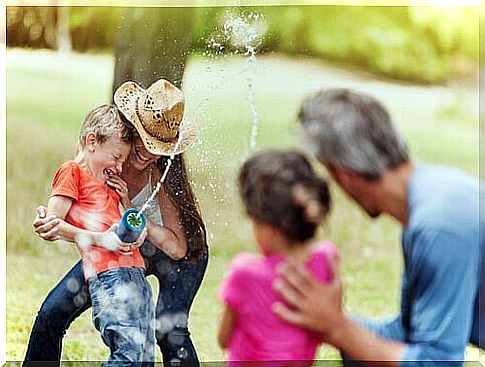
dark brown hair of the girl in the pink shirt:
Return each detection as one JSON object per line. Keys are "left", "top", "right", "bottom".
{"left": 238, "top": 150, "right": 330, "bottom": 243}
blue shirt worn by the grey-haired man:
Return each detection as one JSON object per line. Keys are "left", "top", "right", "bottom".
{"left": 362, "top": 165, "right": 485, "bottom": 367}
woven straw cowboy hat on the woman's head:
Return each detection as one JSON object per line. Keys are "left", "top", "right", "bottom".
{"left": 114, "top": 79, "right": 197, "bottom": 155}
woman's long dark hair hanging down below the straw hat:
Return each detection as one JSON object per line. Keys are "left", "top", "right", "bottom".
{"left": 157, "top": 154, "right": 207, "bottom": 261}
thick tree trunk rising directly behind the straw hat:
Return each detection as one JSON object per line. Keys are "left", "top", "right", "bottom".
{"left": 113, "top": 8, "right": 195, "bottom": 97}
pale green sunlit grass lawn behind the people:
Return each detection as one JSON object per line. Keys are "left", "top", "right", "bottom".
{"left": 7, "top": 50, "right": 478, "bottom": 361}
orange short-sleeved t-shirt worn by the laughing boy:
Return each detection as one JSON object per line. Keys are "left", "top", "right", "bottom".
{"left": 51, "top": 161, "right": 145, "bottom": 279}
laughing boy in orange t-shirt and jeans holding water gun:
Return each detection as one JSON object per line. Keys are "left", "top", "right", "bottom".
{"left": 47, "top": 105, "right": 155, "bottom": 366}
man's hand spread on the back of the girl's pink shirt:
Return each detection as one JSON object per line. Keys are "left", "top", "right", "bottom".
{"left": 273, "top": 254, "right": 345, "bottom": 342}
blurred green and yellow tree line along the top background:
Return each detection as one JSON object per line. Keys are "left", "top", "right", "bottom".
{"left": 7, "top": 6, "right": 479, "bottom": 83}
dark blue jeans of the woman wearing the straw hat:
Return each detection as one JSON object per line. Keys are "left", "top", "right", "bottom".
{"left": 24, "top": 242, "right": 208, "bottom": 366}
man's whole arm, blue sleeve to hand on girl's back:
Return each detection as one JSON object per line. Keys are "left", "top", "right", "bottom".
{"left": 274, "top": 228, "right": 479, "bottom": 366}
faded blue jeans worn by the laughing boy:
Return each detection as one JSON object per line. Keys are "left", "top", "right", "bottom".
{"left": 89, "top": 268, "right": 155, "bottom": 366}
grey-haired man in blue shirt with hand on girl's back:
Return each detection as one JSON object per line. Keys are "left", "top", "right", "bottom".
{"left": 274, "top": 89, "right": 485, "bottom": 366}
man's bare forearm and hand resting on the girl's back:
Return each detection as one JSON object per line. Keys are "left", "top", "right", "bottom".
{"left": 273, "top": 263, "right": 405, "bottom": 367}
